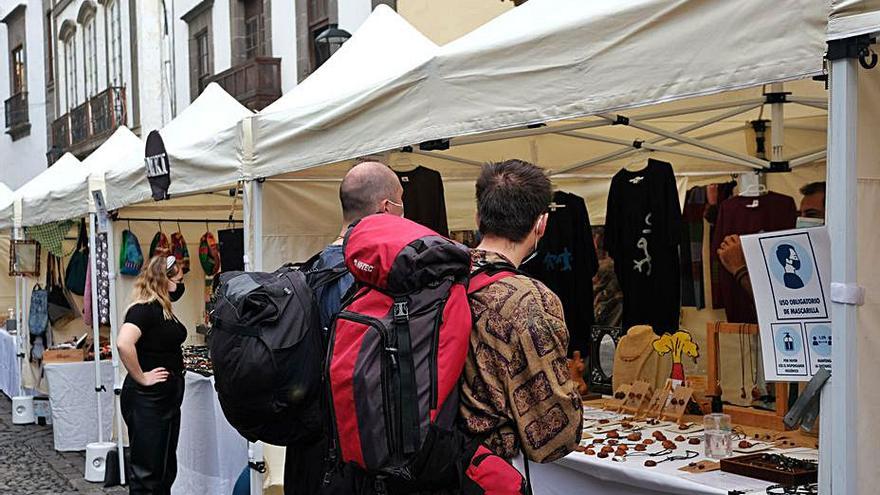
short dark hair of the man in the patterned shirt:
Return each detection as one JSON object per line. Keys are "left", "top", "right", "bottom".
{"left": 477, "top": 160, "right": 553, "bottom": 242}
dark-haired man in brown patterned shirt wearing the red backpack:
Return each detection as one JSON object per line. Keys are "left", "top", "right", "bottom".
{"left": 460, "top": 160, "right": 582, "bottom": 468}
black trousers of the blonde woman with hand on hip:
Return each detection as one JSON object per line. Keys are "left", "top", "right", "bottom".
{"left": 120, "top": 375, "right": 184, "bottom": 495}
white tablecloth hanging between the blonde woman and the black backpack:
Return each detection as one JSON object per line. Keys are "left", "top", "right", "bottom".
{"left": 171, "top": 372, "right": 247, "bottom": 495}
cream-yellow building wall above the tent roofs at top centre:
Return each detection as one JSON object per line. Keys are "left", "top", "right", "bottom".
{"left": 398, "top": 0, "right": 514, "bottom": 45}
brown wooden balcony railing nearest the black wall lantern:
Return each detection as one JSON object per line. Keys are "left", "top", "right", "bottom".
{"left": 209, "top": 57, "right": 281, "bottom": 110}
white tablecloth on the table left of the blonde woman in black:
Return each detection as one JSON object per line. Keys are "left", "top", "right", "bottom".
{"left": 44, "top": 361, "right": 113, "bottom": 451}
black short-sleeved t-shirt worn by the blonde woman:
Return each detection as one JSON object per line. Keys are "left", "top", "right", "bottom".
{"left": 125, "top": 301, "right": 186, "bottom": 372}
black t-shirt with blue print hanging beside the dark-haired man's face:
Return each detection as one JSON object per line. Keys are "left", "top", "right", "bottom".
{"left": 520, "top": 191, "right": 599, "bottom": 356}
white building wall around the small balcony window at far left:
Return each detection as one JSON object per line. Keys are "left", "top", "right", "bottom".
{"left": 0, "top": 0, "right": 47, "bottom": 189}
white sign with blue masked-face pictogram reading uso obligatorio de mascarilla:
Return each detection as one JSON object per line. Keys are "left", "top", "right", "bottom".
{"left": 742, "top": 227, "right": 831, "bottom": 381}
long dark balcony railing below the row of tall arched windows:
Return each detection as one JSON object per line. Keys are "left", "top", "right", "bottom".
{"left": 52, "top": 87, "right": 127, "bottom": 154}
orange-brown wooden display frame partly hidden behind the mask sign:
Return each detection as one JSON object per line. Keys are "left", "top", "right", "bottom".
{"left": 706, "top": 322, "right": 788, "bottom": 431}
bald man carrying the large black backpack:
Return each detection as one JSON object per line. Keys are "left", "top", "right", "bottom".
{"left": 284, "top": 161, "right": 403, "bottom": 495}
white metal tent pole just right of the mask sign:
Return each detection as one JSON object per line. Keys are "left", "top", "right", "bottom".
{"left": 819, "top": 45, "right": 859, "bottom": 495}
